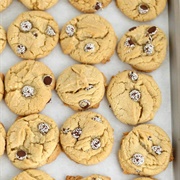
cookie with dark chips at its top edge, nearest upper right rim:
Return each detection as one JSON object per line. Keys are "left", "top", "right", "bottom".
{"left": 117, "top": 25, "right": 167, "bottom": 72}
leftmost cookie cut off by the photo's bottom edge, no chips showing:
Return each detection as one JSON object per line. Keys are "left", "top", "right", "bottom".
{"left": 12, "top": 169, "right": 54, "bottom": 180}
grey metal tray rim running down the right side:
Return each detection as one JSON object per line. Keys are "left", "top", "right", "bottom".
{"left": 168, "top": 0, "right": 180, "bottom": 180}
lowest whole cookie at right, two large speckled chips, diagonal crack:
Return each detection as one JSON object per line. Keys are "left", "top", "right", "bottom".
{"left": 119, "top": 124, "right": 172, "bottom": 176}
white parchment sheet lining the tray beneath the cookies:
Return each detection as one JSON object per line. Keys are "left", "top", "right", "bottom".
{"left": 0, "top": 0, "right": 174, "bottom": 180}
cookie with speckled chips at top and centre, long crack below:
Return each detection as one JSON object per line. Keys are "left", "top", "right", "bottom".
{"left": 107, "top": 71, "right": 161, "bottom": 125}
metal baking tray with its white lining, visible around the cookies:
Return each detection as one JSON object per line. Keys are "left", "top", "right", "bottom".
{"left": 0, "top": 0, "right": 180, "bottom": 180}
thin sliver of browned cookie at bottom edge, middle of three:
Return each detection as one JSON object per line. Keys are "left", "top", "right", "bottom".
{"left": 66, "top": 174, "right": 111, "bottom": 180}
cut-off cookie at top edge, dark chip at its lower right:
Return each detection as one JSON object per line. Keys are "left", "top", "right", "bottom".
{"left": 69, "top": 0, "right": 112, "bottom": 13}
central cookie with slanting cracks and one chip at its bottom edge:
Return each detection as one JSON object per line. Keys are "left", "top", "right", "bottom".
{"left": 56, "top": 64, "right": 106, "bottom": 111}
